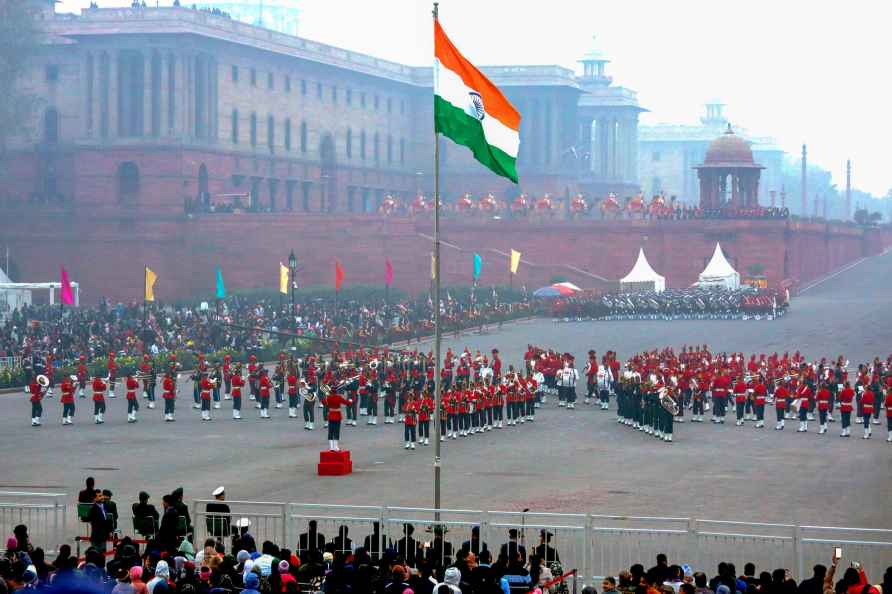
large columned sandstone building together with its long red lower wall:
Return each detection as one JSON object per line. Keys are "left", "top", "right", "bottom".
{"left": 0, "top": 0, "right": 885, "bottom": 303}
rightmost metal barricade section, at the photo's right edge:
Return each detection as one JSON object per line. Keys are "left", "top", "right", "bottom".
{"left": 798, "top": 526, "right": 892, "bottom": 583}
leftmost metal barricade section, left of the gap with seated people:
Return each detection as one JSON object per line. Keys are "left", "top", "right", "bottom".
{"left": 0, "top": 491, "right": 67, "bottom": 553}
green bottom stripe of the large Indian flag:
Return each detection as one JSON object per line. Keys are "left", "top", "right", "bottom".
{"left": 434, "top": 95, "right": 517, "bottom": 183}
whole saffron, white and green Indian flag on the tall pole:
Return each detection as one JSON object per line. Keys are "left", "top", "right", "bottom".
{"left": 434, "top": 20, "right": 520, "bottom": 183}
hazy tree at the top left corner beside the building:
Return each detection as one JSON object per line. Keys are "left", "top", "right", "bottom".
{"left": 0, "top": 0, "right": 38, "bottom": 158}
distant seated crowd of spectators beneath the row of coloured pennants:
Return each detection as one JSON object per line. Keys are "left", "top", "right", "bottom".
{"left": 0, "top": 295, "right": 531, "bottom": 374}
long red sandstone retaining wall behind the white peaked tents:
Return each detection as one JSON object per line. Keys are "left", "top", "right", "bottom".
{"left": 0, "top": 209, "right": 892, "bottom": 303}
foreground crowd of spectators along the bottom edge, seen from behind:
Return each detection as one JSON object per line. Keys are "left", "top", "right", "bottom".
{"left": 0, "top": 504, "right": 892, "bottom": 594}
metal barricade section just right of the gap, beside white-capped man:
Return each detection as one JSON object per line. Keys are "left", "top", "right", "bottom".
{"left": 192, "top": 499, "right": 288, "bottom": 549}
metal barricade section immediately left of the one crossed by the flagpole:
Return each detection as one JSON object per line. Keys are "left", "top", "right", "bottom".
{"left": 287, "top": 503, "right": 387, "bottom": 561}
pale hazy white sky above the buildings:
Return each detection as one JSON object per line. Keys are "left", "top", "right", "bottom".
{"left": 60, "top": 0, "right": 892, "bottom": 196}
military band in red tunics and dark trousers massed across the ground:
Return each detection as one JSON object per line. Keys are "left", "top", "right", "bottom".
{"left": 19, "top": 345, "right": 892, "bottom": 450}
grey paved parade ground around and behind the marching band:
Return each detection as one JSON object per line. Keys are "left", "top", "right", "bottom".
{"left": 0, "top": 249, "right": 892, "bottom": 528}
